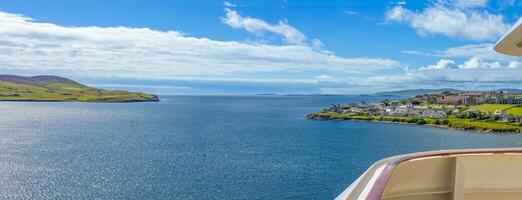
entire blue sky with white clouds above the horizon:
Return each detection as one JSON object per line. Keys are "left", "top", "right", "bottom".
{"left": 0, "top": 0, "right": 522, "bottom": 94}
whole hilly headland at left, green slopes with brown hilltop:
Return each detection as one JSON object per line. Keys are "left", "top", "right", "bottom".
{"left": 0, "top": 75, "right": 159, "bottom": 102}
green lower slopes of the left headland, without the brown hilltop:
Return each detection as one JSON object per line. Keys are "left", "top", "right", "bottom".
{"left": 0, "top": 81, "right": 158, "bottom": 102}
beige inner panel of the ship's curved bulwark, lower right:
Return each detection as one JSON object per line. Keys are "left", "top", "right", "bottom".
{"left": 381, "top": 154, "right": 522, "bottom": 200}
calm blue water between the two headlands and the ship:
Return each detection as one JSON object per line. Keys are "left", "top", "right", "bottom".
{"left": 0, "top": 96, "right": 522, "bottom": 199}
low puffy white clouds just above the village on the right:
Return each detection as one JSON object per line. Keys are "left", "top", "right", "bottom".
{"left": 351, "top": 57, "right": 522, "bottom": 90}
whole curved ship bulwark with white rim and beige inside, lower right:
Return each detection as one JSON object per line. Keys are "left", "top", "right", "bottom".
{"left": 336, "top": 148, "right": 522, "bottom": 200}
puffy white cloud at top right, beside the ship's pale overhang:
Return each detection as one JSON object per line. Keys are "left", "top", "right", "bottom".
{"left": 385, "top": 1, "right": 510, "bottom": 41}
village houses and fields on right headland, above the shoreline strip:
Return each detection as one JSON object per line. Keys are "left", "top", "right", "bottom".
{"left": 322, "top": 91, "right": 522, "bottom": 123}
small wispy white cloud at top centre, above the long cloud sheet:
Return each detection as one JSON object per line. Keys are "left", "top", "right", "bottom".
{"left": 221, "top": 8, "right": 306, "bottom": 44}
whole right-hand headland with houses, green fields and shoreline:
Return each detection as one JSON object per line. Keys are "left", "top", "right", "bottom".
{"left": 306, "top": 90, "right": 522, "bottom": 133}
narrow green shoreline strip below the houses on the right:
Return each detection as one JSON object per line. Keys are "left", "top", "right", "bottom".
{"left": 305, "top": 112, "right": 522, "bottom": 134}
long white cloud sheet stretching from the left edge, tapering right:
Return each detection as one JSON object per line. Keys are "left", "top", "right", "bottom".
{"left": 0, "top": 12, "right": 400, "bottom": 80}
